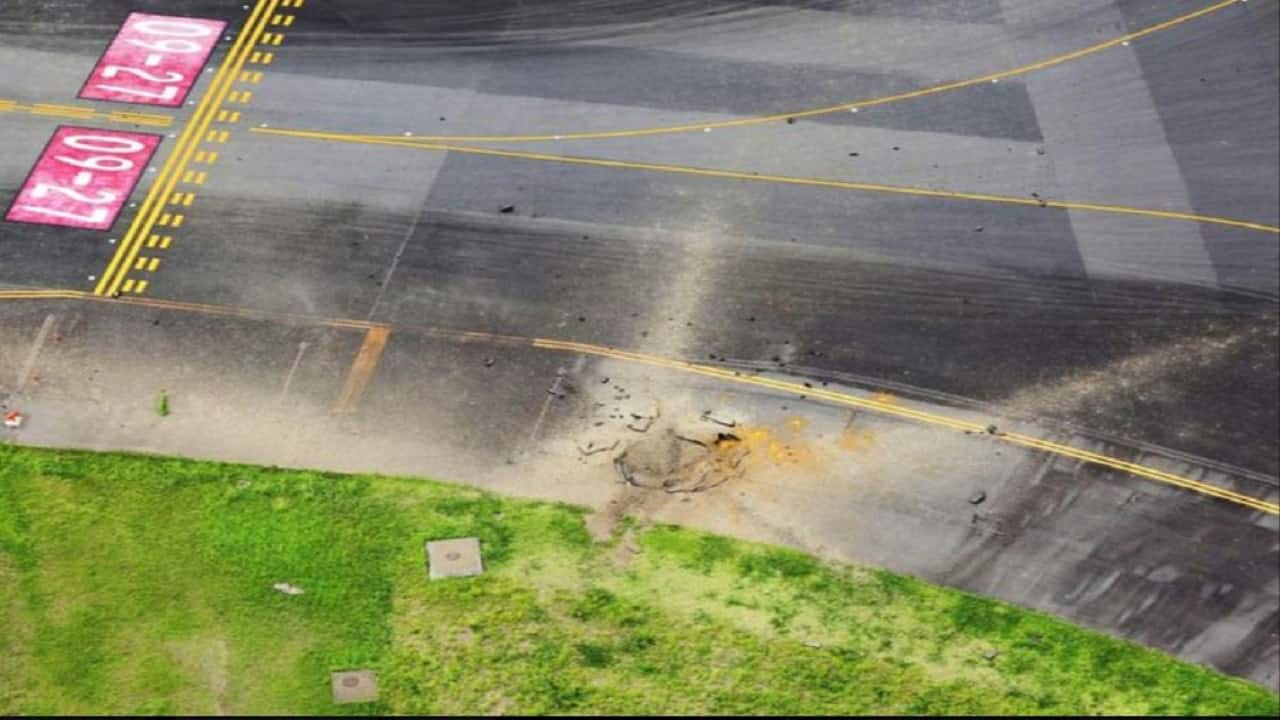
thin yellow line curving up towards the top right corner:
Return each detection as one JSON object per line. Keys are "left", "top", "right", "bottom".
{"left": 285, "top": 0, "right": 1245, "bottom": 142}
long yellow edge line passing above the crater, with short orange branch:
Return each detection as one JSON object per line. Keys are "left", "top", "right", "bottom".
{"left": 0, "top": 288, "right": 1280, "bottom": 515}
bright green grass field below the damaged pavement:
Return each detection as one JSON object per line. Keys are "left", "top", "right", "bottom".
{"left": 0, "top": 445, "right": 1280, "bottom": 716}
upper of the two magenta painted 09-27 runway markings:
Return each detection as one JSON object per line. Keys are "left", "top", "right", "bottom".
{"left": 78, "top": 13, "right": 227, "bottom": 108}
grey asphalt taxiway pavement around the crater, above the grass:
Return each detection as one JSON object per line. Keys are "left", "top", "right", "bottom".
{"left": 0, "top": 0, "right": 1280, "bottom": 685}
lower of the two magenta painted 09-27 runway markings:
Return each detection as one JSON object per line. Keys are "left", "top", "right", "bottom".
{"left": 4, "top": 126, "right": 160, "bottom": 231}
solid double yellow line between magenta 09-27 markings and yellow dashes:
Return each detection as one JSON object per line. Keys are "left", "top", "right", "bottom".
{"left": 93, "top": 0, "right": 280, "bottom": 296}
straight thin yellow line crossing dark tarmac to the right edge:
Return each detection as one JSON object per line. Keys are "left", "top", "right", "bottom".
{"left": 251, "top": 128, "right": 1280, "bottom": 234}
